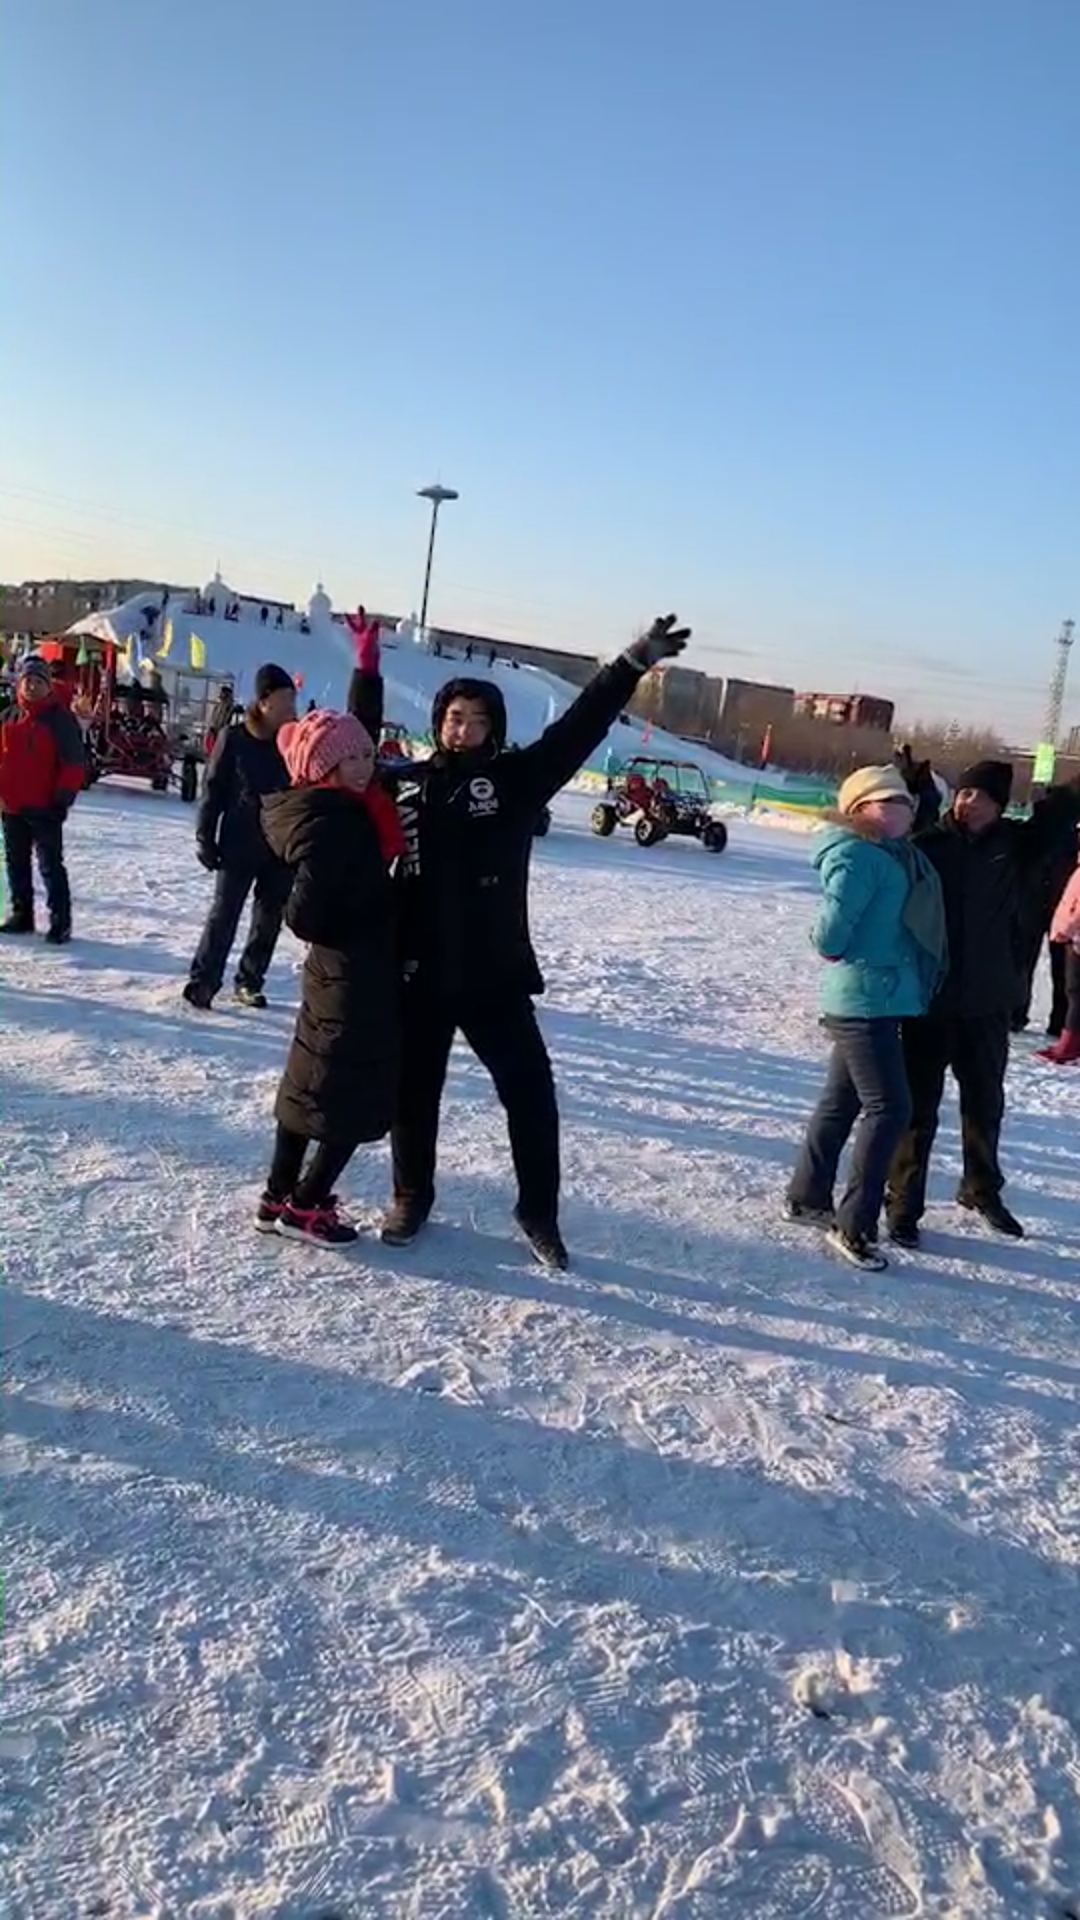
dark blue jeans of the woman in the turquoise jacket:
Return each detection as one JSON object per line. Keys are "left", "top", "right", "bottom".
{"left": 788, "top": 1020, "right": 911, "bottom": 1236}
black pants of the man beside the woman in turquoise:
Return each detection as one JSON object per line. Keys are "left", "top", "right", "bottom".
{"left": 888, "top": 1014, "right": 1011, "bottom": 1223}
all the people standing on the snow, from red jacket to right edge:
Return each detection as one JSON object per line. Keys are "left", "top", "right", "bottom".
{"left": 0, "top": 614, "right": 1080, "bottom": 1269}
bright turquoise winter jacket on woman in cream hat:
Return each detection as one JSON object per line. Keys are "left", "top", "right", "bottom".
{"left": 811, "top": 822, "right": 945, "bottom": 1020}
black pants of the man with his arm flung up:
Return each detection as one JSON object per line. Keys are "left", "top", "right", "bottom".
{"left": 390, "top": 983, "right": 559, "bottom": 1225}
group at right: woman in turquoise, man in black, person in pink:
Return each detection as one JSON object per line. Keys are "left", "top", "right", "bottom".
{"left": 786, "top": 755, "right": 1080, "bottom": 1271}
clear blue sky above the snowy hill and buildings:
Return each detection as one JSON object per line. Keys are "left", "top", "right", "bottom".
{"left": 0, "top": 0, "right": 1080, "bottom": 737}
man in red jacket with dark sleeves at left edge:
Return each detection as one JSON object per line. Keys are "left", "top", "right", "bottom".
{"left": 0, "top": 655, "right": 86, "bottom": 947}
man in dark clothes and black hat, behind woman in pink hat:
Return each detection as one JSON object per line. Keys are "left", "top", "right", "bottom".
{"left": 184, "top": 664, "right": 296, "bottom": 1012}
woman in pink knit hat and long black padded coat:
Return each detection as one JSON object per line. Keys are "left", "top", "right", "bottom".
{"left": 256, "top": 710, "right": 405, "bottom": 1246}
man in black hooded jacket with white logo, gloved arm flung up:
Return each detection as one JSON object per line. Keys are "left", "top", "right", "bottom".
{"left": 350, "top": 614, "right": 690, "bottom": 1267}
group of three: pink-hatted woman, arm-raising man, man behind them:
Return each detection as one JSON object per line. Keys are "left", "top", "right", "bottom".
{"left": 184, "top": 614, "right": 688, "bottom": 1267}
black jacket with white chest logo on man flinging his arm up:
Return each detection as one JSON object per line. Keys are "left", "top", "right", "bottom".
{"left": 350, "top": 659, "right": 642, "bottom": 998}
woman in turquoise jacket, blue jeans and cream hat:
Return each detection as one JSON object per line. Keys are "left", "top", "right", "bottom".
{"left": 786, "top": 766, "right": 945, "bottom": 1271}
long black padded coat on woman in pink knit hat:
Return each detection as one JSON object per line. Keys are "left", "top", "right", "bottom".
{"left": 263, "top": 787, "right": 398, "bottom": 1144}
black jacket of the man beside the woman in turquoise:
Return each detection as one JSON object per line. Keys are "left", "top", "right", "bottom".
{"left": 917, "top": 787, "right": 1080, "bottom": 1020}
